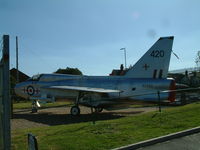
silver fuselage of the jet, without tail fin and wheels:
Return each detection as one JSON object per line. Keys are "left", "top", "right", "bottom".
{"left": 15, "top": 74, "right": 175, "bottom": 107}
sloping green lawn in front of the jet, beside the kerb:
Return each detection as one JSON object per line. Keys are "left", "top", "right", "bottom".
{"left": 12, "top": 103, "right": 200, "bottom": 150}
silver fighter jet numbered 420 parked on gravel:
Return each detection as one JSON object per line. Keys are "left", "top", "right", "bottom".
{"left": 15, "top": 36, "right": 175, "bottom": 116}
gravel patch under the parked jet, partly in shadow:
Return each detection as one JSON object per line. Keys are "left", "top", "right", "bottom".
{"left": 11, "top": 106, "right": 158, "bottom": 130}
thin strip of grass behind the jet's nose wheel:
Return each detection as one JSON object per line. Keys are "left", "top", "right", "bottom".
{"left": 13, "top": 101, "right": 70, "bottom": 109}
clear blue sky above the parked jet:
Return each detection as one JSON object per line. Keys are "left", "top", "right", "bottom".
{"left": 0, "top": 0, "right": 200, "bottom": 75}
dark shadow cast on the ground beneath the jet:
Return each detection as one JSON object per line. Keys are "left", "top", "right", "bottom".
{"left": 13, "top": 111, "right": 143, "bottom": 126}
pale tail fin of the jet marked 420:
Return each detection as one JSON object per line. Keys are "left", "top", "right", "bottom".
{"left": 125, "top": 36, "right": 174, "bottom": 79}
